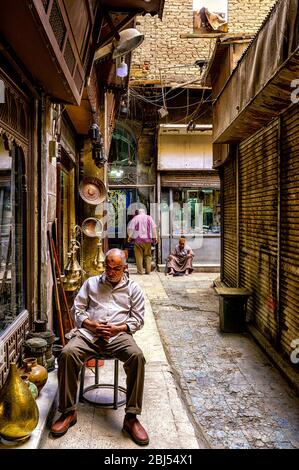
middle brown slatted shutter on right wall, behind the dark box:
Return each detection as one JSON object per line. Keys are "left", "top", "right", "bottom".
{"left": 239, "top": 121, "right": 278, "bottom": 343}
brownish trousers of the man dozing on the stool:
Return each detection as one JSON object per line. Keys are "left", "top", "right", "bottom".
{"left": 58, "top": 331, "right": 145, "bottom": 414}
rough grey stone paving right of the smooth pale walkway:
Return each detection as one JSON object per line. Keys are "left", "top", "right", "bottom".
{"left": 137, "top": 273, "right": 299, "bottom": 449}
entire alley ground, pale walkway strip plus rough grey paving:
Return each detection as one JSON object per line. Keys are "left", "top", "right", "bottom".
{"left": 41, "top": 273, "right": 299, "bottom": 449}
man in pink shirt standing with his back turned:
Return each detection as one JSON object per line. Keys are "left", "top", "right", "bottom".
{"left": 128, "top": 209, "right": 158, "bottom": 274}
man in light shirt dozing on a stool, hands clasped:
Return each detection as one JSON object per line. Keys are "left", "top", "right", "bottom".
{"left": 51, "top": 248, "right": 149, "bottom": 445}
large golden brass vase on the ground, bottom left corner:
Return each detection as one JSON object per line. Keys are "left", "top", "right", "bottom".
{"left": 0, "top": 362, "right": 39, "bottom": 441}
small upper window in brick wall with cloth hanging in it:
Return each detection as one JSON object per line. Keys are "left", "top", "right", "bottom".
{"left": 193, "top": 0, "right": 228, "bottom": 34}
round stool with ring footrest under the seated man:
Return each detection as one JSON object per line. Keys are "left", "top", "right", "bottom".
{"left": 79, "top": 354, "right": 127, "bottom": 410}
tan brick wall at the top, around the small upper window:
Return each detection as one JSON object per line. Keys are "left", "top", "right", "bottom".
{"left": 131, "top": 0, "right": 276, "bottom": 83}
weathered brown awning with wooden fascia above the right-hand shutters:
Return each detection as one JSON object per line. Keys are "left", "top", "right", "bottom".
{"left": 213, "top": 0, "right": 299, "bottom": 143}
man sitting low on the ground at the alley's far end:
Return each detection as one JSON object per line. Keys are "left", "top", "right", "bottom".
{"left": 167, "top": 237, "right": 194, "bottom": 276}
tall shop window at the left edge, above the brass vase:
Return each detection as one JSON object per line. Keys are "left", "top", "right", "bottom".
{"left": 0, "top": 136, "right": 25, "bottom": 332}
